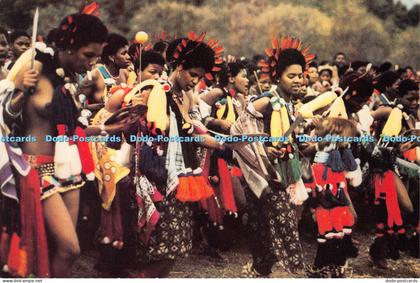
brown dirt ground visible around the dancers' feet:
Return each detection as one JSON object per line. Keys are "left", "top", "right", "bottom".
{"left": 72, "top": 233, "right": 420, "bottom": 278}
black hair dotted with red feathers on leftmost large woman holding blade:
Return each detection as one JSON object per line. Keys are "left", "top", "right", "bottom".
{"left": 55, "top": 14, "right": 108, "bottom": 50}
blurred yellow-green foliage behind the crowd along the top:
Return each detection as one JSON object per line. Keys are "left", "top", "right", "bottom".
{"left": 0, "top": 0, "right": 420, "bottom": 67}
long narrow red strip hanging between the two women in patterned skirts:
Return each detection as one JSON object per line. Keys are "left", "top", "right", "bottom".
{"left": 217, "top": 158, "right": 238, "bottom": 212}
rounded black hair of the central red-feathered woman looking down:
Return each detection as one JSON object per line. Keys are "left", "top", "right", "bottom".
{"left": 166, "top": 38, "right": 215, "bottom": 73}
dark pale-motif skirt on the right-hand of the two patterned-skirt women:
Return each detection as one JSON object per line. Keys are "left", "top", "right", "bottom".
{"left": 246, "top": 189, "right": 303, "bottom": 275}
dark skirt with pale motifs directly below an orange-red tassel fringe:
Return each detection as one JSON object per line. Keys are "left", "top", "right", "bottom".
{"left": 136, "top": 193, "right": 193, "bottom": 264}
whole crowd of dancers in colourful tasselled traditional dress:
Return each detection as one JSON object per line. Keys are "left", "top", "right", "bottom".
{"left": 0, "top": 4, "right": 420, "bottom": 278}
